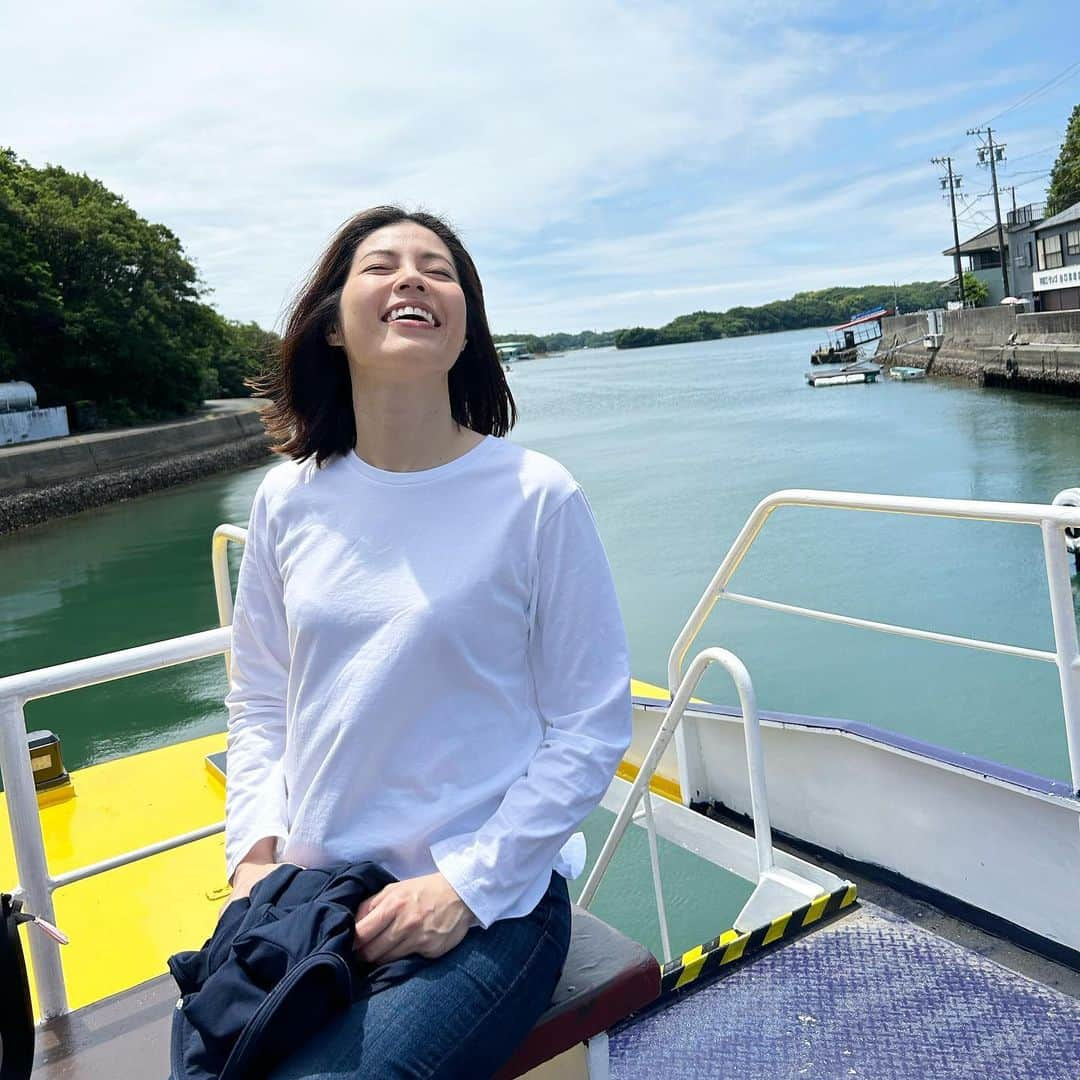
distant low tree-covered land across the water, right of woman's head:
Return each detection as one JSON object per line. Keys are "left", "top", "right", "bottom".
{"left": 495, "top": 281, "right": 953, "bottom": 353}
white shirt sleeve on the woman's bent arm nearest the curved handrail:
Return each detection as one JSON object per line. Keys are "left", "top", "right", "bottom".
{"left": 431, "top": 488, "right": 631, "bottom": 928}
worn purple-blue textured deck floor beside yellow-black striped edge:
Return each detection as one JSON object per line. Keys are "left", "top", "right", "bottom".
{"left": 611, "top": 904, "right": 1080, "bottom": 1080}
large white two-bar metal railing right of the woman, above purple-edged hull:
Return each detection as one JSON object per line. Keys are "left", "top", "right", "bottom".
{"left": 667, "top": 489, "right": 1080, "bottom": 798}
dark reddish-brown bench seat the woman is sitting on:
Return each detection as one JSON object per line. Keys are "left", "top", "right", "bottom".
{"left": 33, "top": 906, "right": 660, "bottom": 1080}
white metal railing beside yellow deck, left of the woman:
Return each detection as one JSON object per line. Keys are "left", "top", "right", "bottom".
{"left": 0, "top": 525, "right": 246, "bottom": 1020}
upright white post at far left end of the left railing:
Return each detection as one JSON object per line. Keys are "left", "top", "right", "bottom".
{"left": 0, "top": 697, "right": 68, "bottom": 1020}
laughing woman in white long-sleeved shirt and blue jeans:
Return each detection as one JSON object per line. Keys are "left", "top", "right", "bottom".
{"left": 226, "top": 206, "right": 631, "bottom": 1080}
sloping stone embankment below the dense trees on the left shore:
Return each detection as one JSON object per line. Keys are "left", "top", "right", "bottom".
{"left": 0, "top": 399, "right": 270, "bottom": 535}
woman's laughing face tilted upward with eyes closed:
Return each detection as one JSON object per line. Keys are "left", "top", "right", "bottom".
{"left": 328, "top": 221, "right": 465, "bottom": 379}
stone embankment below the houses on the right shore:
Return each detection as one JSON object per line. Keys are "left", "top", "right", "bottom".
{"left": 874, "top": 307, "right": 1080, "bottom": 395}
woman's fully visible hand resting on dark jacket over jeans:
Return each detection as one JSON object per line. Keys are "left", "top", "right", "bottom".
{"left": 353, "top": 872, "right": 475, "bottom": 963}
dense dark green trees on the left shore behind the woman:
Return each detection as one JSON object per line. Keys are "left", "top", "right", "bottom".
{"left": 0, "top": 148, "right": 278, "bottom": 424}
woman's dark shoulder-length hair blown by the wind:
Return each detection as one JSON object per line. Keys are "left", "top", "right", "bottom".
{"left": 253, "top": 206, "right": 517, "bottom": 465}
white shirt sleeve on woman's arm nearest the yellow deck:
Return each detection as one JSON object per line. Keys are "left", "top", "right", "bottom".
{"left": 225, "top": 485, "right": 289, "bottom": 881}
